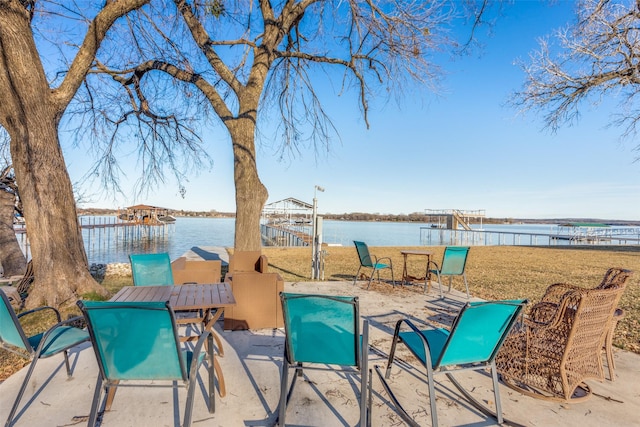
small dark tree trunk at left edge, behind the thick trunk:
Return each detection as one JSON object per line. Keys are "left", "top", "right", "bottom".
{"left": 0, "top": 190, "right": 27, "bottom": 277}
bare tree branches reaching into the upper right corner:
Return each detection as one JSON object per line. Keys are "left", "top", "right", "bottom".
{"left": 513, "top": 0, "right": 640, "bottom": 156}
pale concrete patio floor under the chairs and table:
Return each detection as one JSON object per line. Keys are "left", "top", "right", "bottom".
{"left": 0, "top": 282, "right": 640, "bottom": 427}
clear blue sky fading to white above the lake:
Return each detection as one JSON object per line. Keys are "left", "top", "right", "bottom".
{"left": 65, "top": 1, "right": 640, "bottom": 220}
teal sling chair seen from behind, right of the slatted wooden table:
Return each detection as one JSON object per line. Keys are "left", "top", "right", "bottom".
{"left": 277, "top": 293, "right": 371, "bottom": 426}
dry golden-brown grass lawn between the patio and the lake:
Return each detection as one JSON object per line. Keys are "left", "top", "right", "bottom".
{"left": 0, "top": 246, "right": 640, "bottom": 381}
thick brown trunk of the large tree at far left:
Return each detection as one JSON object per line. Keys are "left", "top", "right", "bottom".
{"left": 0, "top": 3, "right": 106, "bottom": 308}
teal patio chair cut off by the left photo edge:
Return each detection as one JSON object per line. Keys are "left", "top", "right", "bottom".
{"left": 0, "top": 291, "right": 89, "bottom": 426}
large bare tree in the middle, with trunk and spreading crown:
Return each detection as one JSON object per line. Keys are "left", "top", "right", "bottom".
{"left": 85, "top": 0, "right": 488, "bottom": 250}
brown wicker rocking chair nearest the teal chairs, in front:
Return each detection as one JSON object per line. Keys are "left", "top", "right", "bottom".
{"left": 496, "top": 285, "right": 624, "bottom": 402}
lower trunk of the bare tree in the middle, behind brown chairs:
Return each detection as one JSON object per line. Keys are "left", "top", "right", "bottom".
{"left": 228, "top": 120, "right": 269, "bottom": 251}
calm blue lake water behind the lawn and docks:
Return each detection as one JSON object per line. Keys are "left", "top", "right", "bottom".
{"left": 74, "top": 217, "right": 637, "bottom": 264}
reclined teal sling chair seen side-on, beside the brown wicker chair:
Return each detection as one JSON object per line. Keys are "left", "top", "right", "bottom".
{"left": 376, "top": 300, "right": 527, "bottom": 427}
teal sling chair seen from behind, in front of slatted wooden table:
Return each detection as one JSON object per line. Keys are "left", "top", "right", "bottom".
{"left": 78, "top": 301, "right": 215, "bottom": 427}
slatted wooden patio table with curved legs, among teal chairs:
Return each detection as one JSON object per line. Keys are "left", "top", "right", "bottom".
{"left": 106, "top": 283, "right": 236, "bottom": 410}
